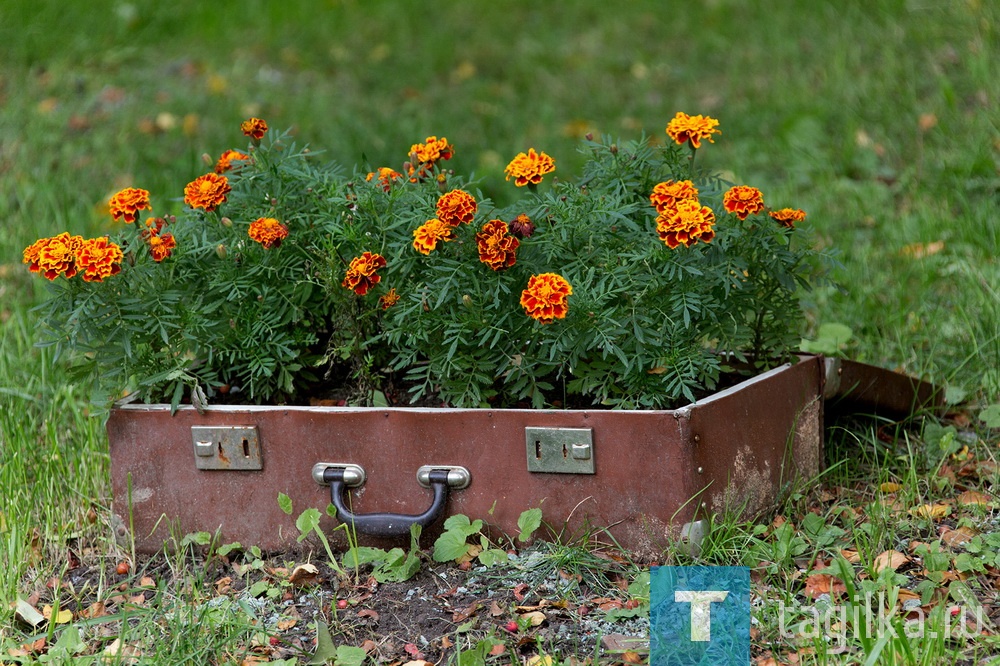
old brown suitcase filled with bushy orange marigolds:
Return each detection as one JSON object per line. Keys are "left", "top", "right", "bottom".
{"left": 33, "top": 113, "right": 928, "bottom": 553}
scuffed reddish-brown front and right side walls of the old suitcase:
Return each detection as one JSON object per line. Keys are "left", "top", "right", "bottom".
{"left": 107, "top": 357, "right": 825, "bottom": 556}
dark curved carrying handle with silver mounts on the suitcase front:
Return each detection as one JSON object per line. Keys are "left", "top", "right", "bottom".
{"left": 314, "top": 463, "right": 470, "bottom": 537}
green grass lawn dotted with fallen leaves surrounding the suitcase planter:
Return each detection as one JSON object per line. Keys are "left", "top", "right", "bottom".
{"left": 0, "top": 0, "right": 1000, "bottom": 664}
